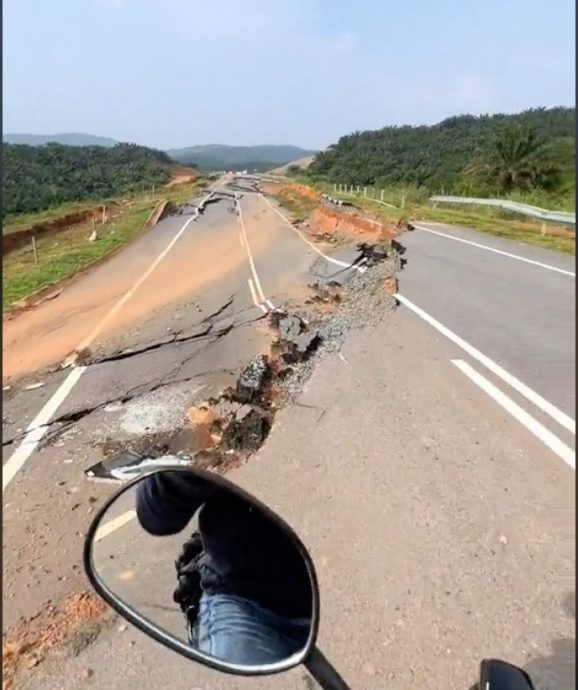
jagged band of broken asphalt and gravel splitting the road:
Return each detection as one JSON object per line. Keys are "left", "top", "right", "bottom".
{"left": 90, "top": 232, "right": 399, "bottom": 478}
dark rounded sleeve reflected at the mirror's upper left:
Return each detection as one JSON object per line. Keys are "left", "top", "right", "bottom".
{"left": 136, "top": 471, "right": 215, "bottom": 536}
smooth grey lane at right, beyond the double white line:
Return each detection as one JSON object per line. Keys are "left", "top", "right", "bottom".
{"left": 401, "top": 223, "right": 576, "bottom": 415}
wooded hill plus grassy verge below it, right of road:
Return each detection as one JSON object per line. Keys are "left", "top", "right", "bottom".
{"left": 274, "top": 108, "right": 576, "bottom": 254}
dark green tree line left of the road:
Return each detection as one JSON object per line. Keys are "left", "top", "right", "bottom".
{"left": 2, "top": 143, "right": 172, "bottom": 219}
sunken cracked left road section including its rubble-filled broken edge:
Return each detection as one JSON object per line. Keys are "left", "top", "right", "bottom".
{"left": 3, "top": 175, "right": 400, "bottom": 688}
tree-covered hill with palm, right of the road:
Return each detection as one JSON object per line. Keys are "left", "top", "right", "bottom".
{"left": 307, "top": 107, "right": 576, "bottom": 195}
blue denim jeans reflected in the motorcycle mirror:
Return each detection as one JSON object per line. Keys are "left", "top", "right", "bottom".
{"left": 191, "top": 593, "right": 311, "bottom": 666}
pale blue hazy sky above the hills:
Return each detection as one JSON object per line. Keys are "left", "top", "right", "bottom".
{"left": 2, "top": 0, "right": 575, "bottom": 149}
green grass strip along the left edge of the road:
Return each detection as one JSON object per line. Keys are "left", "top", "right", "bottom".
{"left": 2, "top": 177, "right": 198, "bottom": 311}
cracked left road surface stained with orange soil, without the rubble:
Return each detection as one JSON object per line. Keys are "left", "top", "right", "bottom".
{"left": 3, "top": 176, "right": 364, "bottom": 628}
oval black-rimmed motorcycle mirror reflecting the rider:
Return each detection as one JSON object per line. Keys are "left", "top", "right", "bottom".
{"left": 84, "top": 465, "right": 323, "bottom": 675}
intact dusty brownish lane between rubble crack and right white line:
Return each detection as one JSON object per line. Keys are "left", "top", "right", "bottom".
{"left": 16, "top": 309, "right": 575, "bottom": 690}
